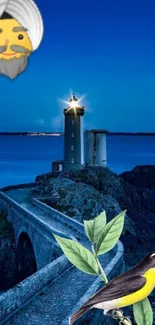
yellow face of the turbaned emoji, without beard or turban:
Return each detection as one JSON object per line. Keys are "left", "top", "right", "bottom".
{"left": 0, "top": 18, "right": 33, "bottom": 60}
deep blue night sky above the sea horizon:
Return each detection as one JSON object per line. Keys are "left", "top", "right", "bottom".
{"left": 0, "top": 0, "right": 155, "bottom": 131}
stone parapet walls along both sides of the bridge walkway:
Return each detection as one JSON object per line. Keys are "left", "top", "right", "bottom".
{"left": 0, "top": 192, "right": 123, "bottom": 325}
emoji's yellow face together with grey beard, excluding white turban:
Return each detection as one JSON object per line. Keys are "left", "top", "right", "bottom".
{"left": 0, "top": 13, "right": 33, "bottom": 79}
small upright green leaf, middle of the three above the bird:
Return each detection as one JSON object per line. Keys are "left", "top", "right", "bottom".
{"left": 84, "top": 211, "right": 106, "bottom": 243}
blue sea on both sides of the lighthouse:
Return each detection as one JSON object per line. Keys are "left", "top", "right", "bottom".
{"left": 0, "top": 135, "right": 155, "bottom": 187}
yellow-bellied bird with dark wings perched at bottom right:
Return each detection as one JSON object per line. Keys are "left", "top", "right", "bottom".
{"left": 69, "top": 252, "right": 155, "bottom": 325}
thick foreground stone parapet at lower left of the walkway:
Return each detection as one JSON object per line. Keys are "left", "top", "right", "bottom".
{"left": 0, "top": 255, "right": 73, "bottom": 324}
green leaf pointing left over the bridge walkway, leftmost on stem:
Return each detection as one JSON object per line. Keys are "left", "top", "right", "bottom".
{"left": 53, "top": 234, "right": 98, "bottom": 275}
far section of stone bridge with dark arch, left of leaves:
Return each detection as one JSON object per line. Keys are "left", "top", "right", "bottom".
{"left": 0, "top": 192, "right": 84, "bottom": 274}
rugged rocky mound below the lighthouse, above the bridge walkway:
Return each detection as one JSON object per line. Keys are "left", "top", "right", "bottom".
{"left": 35, "top": 177, "right": 134, "bottom": 233}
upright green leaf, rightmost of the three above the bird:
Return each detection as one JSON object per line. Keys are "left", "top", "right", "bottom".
{"left": 96, "top": 210, "right": 126, "bottom": 255}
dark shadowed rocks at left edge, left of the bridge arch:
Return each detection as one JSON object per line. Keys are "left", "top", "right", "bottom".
{"left": 0, "top": 210, "right": 17, "bottom": 290}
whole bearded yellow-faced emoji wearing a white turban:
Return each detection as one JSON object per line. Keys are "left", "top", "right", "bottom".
{"left": 0, "top": 0, "right": 44, "bottom": 79}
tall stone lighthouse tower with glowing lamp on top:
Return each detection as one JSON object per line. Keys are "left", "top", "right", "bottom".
{"left": 63, "top": 94, "right": 84, "bottom": 171}
